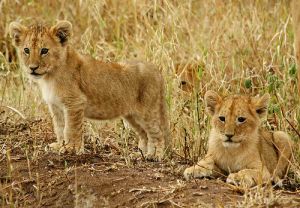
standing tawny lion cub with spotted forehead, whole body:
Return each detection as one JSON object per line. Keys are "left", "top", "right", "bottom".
{"left": 9, "top": 21, "right": 169, "bottom": 160}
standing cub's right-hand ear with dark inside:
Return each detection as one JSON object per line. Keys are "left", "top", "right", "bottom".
{"left": 51, "top": 20, "right": 72, "bottom": 46}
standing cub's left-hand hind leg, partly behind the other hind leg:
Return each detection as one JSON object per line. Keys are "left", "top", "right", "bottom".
{"left": 125, "top": 115, "right": 148, "bottom": 155}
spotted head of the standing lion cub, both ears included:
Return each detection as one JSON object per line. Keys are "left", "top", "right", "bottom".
{"left": 9, "top": 21, "right": 72, "bottom": 79}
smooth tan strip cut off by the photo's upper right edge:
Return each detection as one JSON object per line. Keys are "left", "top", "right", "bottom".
{"left": 291, "top": 0, "right": 300, "bottom": 95}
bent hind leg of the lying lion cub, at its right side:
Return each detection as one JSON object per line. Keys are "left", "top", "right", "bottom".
{"left": 273, "top": 131, "right": 293, "bottom": 178}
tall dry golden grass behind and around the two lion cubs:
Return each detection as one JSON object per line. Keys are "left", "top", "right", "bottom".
{"left": 0, "top": 0, "right": 300, "bottom": 207}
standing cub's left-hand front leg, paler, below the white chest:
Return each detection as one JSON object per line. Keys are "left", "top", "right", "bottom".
{"left": 49, "top": 104, "right": 65, "bottom": 151}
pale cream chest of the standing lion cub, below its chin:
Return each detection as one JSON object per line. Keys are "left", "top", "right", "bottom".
{"left": 39, "top": 81, "right": 59, "bottom": 104}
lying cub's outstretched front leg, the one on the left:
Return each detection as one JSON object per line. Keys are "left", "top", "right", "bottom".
{"left": 183, "top": 155, "right": 221, "bottom": 180}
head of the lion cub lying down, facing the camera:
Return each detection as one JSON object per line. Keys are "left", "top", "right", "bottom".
{"left": 205, "top": 91, "right": 270, "bottom": 147}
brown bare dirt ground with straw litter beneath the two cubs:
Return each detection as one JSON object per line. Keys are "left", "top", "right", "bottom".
{"left": 0, "top": 114, "right": 300, "bottom": 207}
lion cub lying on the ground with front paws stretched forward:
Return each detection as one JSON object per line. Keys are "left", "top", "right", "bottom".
{"left": 184, "top": 91, "right": 292, "bottom": 187}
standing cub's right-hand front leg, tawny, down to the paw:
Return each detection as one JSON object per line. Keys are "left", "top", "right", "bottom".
{"left": 61, "top": 105, "right": 84, "bottom": 154}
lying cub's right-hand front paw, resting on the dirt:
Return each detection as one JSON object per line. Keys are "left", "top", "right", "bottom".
{"left": 226, "top": 172, "right": 256, "bottom": 188}
